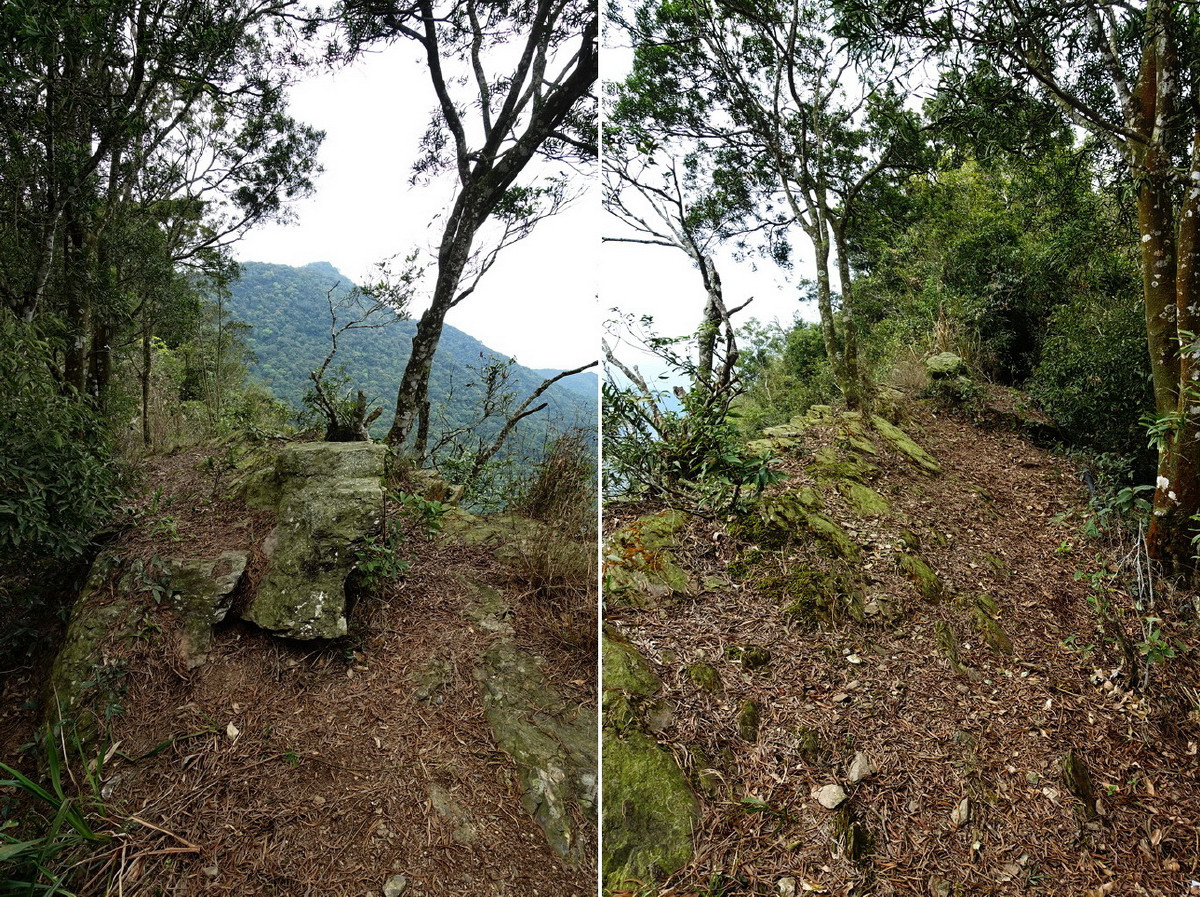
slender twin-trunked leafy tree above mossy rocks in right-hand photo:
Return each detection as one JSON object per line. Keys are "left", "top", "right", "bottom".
{"left": 623, "top": 0, "right": 916, "bottom": 407}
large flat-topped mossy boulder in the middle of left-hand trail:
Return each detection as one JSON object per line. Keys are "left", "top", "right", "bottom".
{"left": 242, "top": 443, "right": 388, "bottom": 639}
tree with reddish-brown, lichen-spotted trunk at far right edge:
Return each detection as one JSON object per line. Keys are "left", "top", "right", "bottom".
{"left": 840, "top": 0, "right": 1200, "bottom": 567}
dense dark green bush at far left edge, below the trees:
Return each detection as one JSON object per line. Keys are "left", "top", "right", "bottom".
{"left": 0, "top": 313, "right": 121, "bottom": 564}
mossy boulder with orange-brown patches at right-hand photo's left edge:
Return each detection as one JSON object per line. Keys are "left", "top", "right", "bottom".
{"left": 604, "top": 511, "right": 696, "bottom": 607}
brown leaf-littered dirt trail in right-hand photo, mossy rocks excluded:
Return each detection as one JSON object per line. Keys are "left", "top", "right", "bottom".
{"left": 606, "top": 405, "right": 1200, "bottom": 897}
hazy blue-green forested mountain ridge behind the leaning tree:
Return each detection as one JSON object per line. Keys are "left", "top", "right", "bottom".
{"left": 229, "top": 261, "right": 598, "bottom": 450}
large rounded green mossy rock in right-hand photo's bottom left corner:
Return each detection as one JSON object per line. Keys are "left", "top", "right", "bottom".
{"left": 601, "top": 726, "right": 700, "bottom": 891}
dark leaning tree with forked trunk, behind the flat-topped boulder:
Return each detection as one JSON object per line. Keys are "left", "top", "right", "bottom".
{"left": 341, "top": 0, "right": 598, "bottom": 457}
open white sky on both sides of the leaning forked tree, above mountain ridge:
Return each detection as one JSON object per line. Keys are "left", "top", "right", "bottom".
{"left": 234, "top": 42, "right": 600, "bottom": 369}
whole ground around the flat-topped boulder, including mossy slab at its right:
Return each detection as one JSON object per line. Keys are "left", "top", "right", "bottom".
{"left": 0, "top": 450, "right": 595, "bottom": 897}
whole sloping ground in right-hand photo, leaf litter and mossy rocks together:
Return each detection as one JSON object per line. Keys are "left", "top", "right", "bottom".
{"left": 604, "top": 393, "right": 1200, "bottom": 897}
